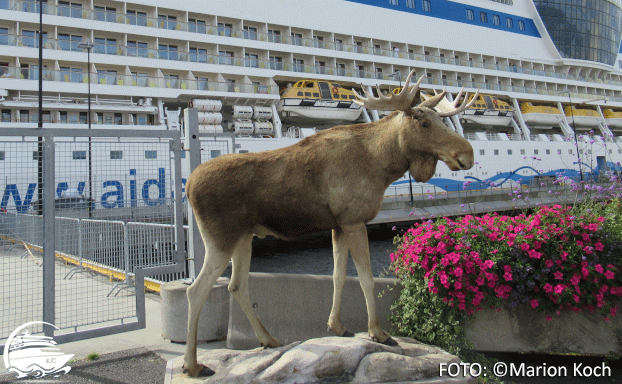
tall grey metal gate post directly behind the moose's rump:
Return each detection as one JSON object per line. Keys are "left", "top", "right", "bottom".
{"left": 185, "top": 108, "right": 205, "bottom": 279}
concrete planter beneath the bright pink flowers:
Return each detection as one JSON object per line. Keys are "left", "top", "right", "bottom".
{"left": 466, "top": 305, "right": 622, "bottom": 355}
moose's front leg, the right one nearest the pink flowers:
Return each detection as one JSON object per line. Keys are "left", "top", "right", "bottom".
{"left": 343, "top": 223, "right": 397, "bottom": 345}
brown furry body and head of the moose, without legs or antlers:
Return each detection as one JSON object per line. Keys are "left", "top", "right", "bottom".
{"left": 186, "top": 108, "right": 472, "bottom": 251}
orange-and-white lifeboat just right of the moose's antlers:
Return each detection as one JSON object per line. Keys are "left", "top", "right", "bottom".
{"left": 458, "top": 95, "right": 514, "bottom": 127}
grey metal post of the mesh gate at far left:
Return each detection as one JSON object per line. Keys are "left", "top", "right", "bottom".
{"left": 43, "top": 134, "right": 56, "bottom": 337}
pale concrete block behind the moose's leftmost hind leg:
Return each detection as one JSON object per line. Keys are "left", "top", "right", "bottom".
{"left": 160, "top": 278, "right": 229, "bottom": 343}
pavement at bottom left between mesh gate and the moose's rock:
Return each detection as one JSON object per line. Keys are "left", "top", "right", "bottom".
{"left": 0, "top": 294, "right": 226, "bottom": 384}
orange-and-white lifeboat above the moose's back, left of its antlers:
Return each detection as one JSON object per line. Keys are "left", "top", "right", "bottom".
{"left": 276, "top": 80, "right": 363, "bottom": 121}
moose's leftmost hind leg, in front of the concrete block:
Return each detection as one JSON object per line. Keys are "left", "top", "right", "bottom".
{"left": 184, "top": 241, "right": 229, "bottom": 377}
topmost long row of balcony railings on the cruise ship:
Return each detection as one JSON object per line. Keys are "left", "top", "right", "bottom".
{"left": 0, "top": 0, "right": 602, "bottom": 83}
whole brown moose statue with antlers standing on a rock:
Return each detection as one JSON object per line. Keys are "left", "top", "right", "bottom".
{"left": 184, "top": 71, "right": 476, "bottom": 376}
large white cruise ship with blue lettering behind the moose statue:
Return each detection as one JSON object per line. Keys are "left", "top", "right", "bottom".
{"left": 0, "top": 0, "right": 622, "bottom": 212}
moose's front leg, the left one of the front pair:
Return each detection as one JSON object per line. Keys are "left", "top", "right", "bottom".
{"left": 328, "top": 228, "right": 354, "bottom": 337}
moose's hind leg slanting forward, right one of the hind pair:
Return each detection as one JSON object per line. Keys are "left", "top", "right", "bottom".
{"left": 229, "top": 234, "right": 281, "bottom": 348}
